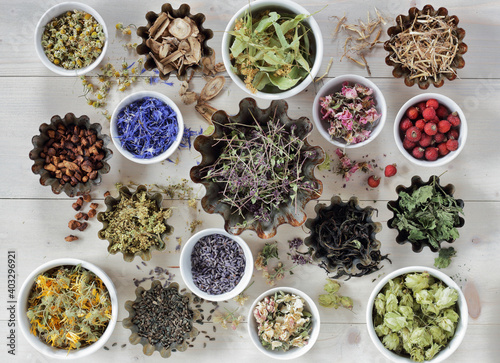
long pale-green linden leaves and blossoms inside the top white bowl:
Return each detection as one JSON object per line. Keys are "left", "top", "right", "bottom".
{"left": 229, "top": 10, "right": 313, "bottom": 93}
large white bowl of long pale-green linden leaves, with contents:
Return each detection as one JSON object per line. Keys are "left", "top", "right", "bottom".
{"left": 222, "top": 0, "right": 323, "bottom": 99}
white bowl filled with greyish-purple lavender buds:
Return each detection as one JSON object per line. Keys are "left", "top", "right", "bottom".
{"left": 180, "top": 228, "right": 253, "bottom": 301}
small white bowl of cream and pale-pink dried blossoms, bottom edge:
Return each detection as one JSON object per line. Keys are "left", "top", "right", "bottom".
{"left": 248, "top": 287, "right": 320, "bottom": 360}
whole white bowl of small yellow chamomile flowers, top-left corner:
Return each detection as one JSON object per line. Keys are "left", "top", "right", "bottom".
{"left": 35, "top": 2, "right": 108, "bottom": 76}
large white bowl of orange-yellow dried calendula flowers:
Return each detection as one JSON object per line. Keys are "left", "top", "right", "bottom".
{"left": 16, "top": 258, "right": 118, "bottom": 359}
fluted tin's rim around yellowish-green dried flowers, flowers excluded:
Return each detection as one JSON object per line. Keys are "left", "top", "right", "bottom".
{"left": 97, "top": 185, "right": 174, "bottom": 262}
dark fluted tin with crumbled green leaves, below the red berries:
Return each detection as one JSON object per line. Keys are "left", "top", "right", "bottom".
{"left": 387, "top": 175, "right": 465, "bottom": 252}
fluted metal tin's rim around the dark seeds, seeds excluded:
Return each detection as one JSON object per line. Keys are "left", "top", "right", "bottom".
{"left": 122, "top": 280, "right": 201, "bottom": 358}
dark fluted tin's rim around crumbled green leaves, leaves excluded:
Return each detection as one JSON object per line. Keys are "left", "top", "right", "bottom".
{"left": 387, "top": 175, "right": 465, "bottom": 252}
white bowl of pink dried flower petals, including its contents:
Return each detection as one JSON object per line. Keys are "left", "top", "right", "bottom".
{"left": 313, "top": 74, "right": 387, "bottom": 148}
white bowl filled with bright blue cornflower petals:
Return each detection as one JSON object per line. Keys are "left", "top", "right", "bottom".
{"left": 110, "top": 91, "right": 184, "bottom": 164}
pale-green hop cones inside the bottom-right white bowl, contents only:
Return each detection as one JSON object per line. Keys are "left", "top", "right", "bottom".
{"left": 373, "top": 272, "right": 460, "bottom": 362}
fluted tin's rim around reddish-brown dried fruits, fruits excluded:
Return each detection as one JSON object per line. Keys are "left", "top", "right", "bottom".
{"left": 29, "top": 113, "right": 113, "bottom": 197}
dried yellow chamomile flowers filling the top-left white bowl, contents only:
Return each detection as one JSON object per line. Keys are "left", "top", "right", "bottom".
{"left": 41, "top": 10, "right": 106, "bottom": 69}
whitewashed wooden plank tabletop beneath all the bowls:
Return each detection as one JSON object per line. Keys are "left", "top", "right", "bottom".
{"left": 0, "top": 0, "right": 500, "bottom": 363}
